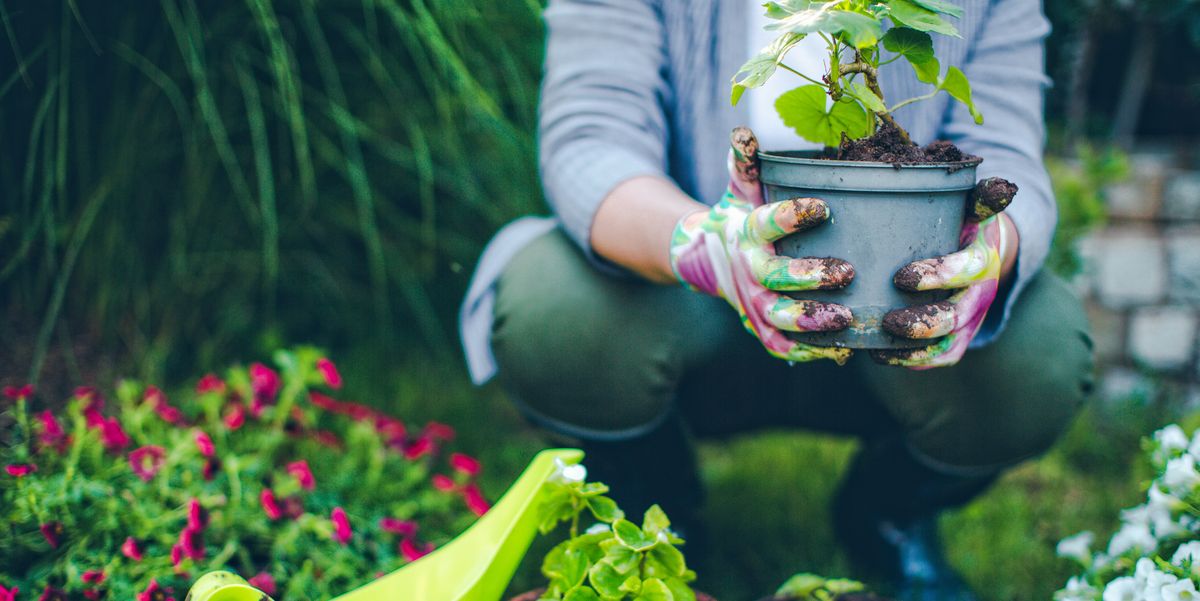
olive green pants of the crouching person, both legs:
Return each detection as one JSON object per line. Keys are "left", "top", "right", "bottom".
{"left": 492, "top": 230, "right": 1092, "bottom": 473}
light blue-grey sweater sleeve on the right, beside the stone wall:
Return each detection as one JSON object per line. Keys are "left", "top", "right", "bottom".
{"left": 943, "top": 0, "right": 1058, "bottom": 347}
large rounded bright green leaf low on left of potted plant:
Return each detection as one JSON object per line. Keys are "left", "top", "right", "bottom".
{"left": 775, "top": 84, "right": 871, "bottom": 146}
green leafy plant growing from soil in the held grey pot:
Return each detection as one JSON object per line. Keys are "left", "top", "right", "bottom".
{"left": 732, "top": 0, "right": 983, "bottom": 146}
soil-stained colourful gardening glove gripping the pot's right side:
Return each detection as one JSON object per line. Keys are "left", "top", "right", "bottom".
{"left": 871, "top": 178, "right": 1016, "bottom": 369}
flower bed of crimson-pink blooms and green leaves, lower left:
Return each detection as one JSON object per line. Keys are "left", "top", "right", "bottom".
{"left": 0, "top": 348, "right": 488, "bottom": 601}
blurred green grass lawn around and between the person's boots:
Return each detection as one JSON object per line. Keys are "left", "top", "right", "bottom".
{"left": 342, "top": 350, "right": 1163, "bottom": 601}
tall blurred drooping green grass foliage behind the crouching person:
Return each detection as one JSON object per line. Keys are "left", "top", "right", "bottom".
{"left": 0, "top": 0, "right": 542, "bottom": 379}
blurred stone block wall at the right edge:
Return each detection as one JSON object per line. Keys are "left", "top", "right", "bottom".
{"left": 1074, "top": 149, "right": 1200, "bottom": 407}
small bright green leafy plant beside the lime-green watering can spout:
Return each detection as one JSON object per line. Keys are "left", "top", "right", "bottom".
{"left": 539, "top": 468, "right": 696, "bottom": 601}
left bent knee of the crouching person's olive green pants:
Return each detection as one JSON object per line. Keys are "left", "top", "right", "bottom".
{"left": 492, "top": 231, "right": 677, "bottom": 438}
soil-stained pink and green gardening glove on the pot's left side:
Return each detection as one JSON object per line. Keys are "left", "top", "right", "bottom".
{"left": 671, "top": 127, "right": 854, "bottom": 365}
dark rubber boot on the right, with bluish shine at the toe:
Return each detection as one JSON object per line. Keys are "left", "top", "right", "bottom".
{"left": 833, "top": 439, "right": 996, "bottom": 601}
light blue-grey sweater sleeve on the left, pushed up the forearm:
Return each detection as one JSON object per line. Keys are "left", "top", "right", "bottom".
{"left": 538, "top": 0, "right": 670, "bottom": 254}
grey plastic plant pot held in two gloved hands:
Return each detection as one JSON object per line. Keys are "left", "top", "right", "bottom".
{"left": 758, "top": 151, "right": 980, "bottom": 349}
